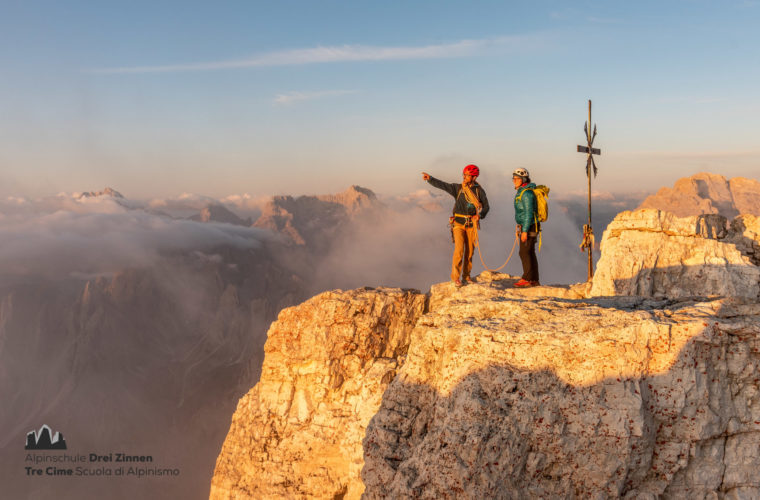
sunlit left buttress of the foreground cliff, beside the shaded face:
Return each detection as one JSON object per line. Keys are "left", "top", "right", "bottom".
{"left": 211, "top": 289, "right": 426, "bottom": 498}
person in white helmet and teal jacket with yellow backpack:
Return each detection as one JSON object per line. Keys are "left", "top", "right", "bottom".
{"left": 512, "top": 168, "right": 549, "bottom": 288}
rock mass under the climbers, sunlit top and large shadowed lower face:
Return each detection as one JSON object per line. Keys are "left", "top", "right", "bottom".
{"left": 362, "top": 280, "right": 760, "bottom": 499}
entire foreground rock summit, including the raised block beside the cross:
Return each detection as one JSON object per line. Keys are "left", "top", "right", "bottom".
{"left": 212, "top": 210, "right": 760, "bottom": 498}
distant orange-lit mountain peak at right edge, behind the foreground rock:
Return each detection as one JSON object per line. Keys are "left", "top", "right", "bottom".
{"left": 639, "top": 172, "right": 760, "bottom": 218}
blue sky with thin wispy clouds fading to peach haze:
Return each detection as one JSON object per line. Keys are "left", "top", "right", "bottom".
{"left": 0, "top": 0, "right": 760, "bottom": 198}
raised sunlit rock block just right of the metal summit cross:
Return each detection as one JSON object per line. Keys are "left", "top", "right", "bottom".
{"left": 591, "top": 209, "right": 760, "bottom": 299}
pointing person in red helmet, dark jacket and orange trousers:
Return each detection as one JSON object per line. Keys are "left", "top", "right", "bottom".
{"left": 422, "top": 165, "right": 488, "bottom": 286}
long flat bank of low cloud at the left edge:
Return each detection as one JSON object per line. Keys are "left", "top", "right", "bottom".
{"left": 0, "top": 195, "right": 269, "bottom": 277}
